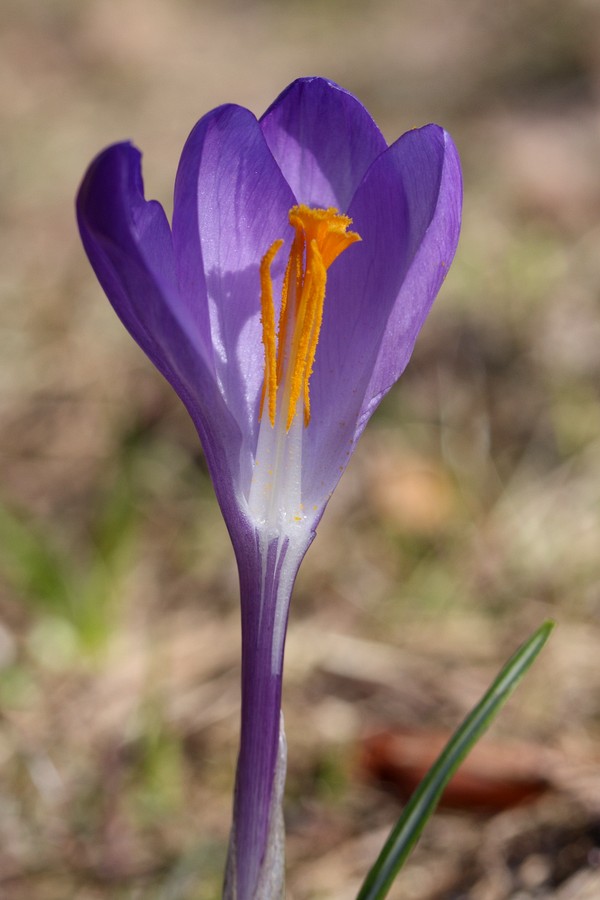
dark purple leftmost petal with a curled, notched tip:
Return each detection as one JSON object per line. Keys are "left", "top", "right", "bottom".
{"left": 77, "top": 144, "right": 241, "bottom": 527}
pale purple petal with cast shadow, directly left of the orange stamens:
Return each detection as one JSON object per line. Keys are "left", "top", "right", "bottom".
{"left": 173, "top": 106, "right": 295, "bottom": 462}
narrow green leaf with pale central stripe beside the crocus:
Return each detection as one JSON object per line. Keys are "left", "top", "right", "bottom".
{"left": 357, "top": 621, "right": 554, "bottom": 900}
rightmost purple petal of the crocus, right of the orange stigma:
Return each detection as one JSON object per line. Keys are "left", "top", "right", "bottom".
{"left": 303, "top": 125, "right": 462, "bottom": 507}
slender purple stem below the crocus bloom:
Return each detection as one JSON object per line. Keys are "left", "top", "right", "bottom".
{"left": 224, "top": 536, "right": 304, "bottom": 900}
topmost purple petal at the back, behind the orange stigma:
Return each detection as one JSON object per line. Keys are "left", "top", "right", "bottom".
{"left": 260, "top": 78, "right": 387, "bottom": 212}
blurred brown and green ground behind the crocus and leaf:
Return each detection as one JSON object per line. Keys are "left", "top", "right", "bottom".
{"left": 0, "top": 0, "right": 600, "bottom": 900}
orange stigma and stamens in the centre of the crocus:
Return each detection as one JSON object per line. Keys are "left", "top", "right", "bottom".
{"left": 259, "top": 206, "right": 360, "bottom": 431}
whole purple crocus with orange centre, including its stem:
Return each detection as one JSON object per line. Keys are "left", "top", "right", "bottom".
{"left": 77, "top": 78, "right": 461, "bottom": 900}
